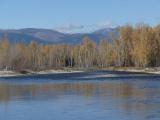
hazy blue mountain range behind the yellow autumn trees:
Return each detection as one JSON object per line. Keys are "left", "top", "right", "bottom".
{"left": 0, "top": 28, "right": 118, "bottom": 44}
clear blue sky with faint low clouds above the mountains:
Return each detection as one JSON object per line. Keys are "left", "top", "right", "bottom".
{"left": 0, "top": 0, "right": 160, "bottom": 32}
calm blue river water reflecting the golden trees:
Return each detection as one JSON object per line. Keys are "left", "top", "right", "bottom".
{"left": 0, "top": 72, "right": 160, "bottom": 120}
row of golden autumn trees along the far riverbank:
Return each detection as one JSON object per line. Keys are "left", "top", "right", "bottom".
{"left": 0, "top": 24, "right": 160, "bottom": 70}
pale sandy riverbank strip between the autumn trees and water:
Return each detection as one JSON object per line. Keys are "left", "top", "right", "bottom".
{"left": 0, "top": 67, "right": 160, "bottom": 77}
